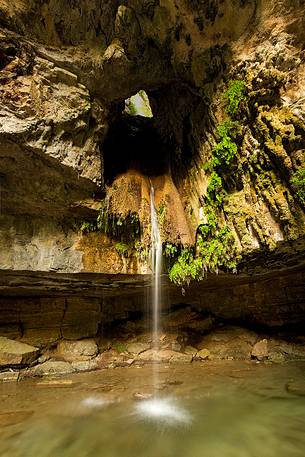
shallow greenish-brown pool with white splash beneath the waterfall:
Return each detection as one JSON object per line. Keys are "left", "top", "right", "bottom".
{"left": 0, "top": 362, "right": 305, "bottom": 457}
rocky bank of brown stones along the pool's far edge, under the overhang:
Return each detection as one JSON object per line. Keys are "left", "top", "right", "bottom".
{"left": 0, "top": 314, "right": 305, "bottom": 381}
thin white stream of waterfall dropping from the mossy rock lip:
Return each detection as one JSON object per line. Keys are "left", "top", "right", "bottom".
{"left": 150, "top": 187, "right": 162, "bottom": 349}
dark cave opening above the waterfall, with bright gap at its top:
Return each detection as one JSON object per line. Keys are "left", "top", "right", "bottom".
{"left": 103, "top": 90, "right": 169, "bottom": 185}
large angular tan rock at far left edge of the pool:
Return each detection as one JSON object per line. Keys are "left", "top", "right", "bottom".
{"left": 0, "top": 336, "right": 39, "bottom": 366}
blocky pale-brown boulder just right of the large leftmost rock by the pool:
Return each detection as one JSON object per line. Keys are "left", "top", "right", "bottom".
{"left": 57, "top": 339, "right": 98, "bottom": 362}
